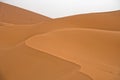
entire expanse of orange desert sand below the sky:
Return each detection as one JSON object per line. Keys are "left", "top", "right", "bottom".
{"left": 0, "top": 3, "right": 120, "bottom": 80}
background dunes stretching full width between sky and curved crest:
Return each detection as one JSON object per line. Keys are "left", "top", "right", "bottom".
{"left": 0, "top": 3, "right": 120, "bottom": 49}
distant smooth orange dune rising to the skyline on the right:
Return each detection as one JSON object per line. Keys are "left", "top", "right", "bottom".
{"left": 54, "top": 11, "right": 120, "bottom": 31}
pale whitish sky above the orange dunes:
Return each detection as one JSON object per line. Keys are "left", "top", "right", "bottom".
{"left": 1, "top": 0, "right": 120, "bottom": 18}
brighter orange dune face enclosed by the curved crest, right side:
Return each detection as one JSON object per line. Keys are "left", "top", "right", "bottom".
{"left": 26, "top": 28, "right": 120, "bottom": 80}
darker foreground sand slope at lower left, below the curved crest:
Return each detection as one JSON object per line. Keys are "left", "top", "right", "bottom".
{"left": 0, "top": 43, "right": 84, "bottom": 80}
